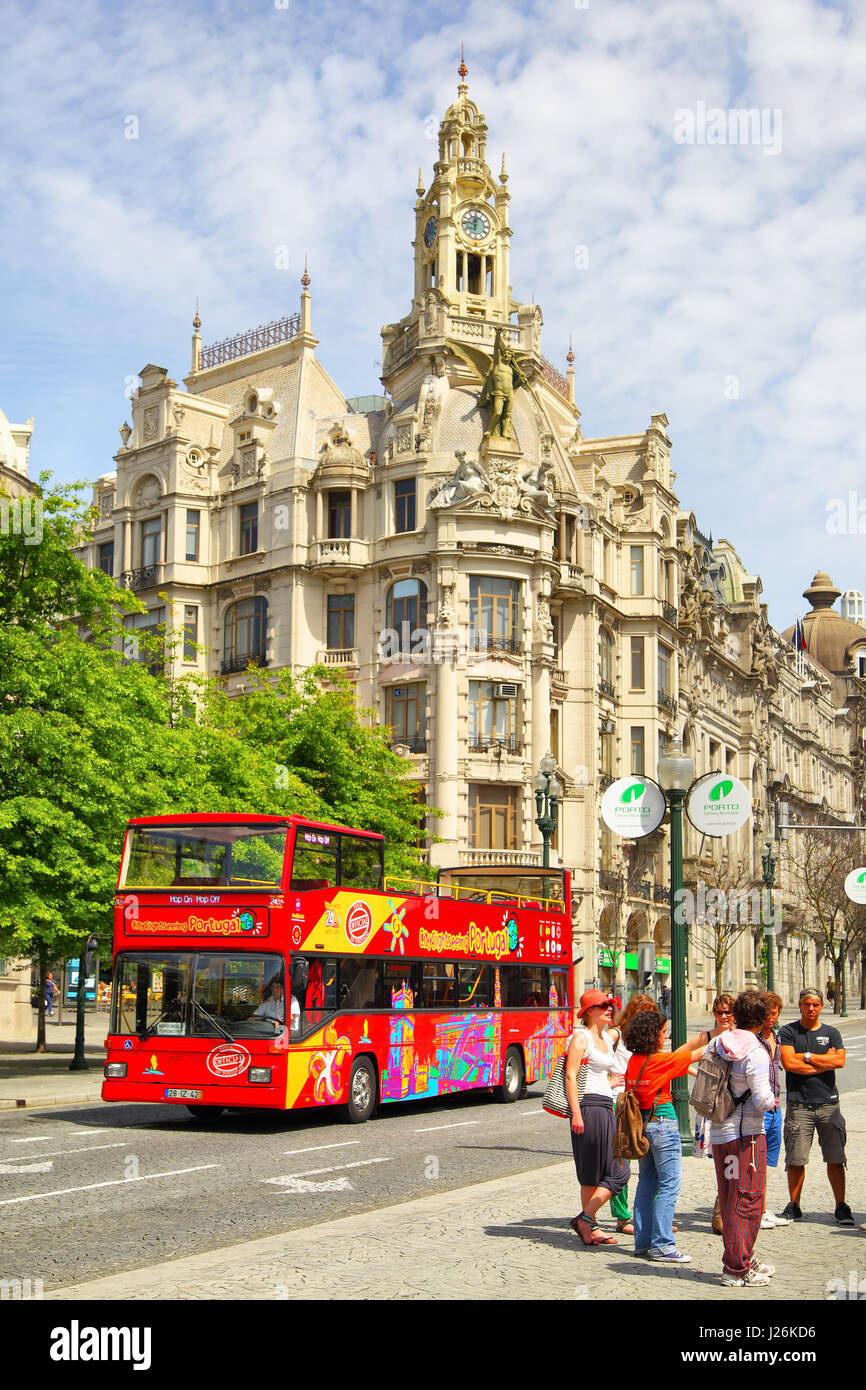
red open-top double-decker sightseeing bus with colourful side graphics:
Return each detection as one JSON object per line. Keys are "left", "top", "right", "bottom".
{"left": 103, "top": 815, "right": 571, "bottom": 1122}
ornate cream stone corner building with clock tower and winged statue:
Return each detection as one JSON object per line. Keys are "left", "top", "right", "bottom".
{"left": 79, "top": 67, "right": 861, "bottom": 1011}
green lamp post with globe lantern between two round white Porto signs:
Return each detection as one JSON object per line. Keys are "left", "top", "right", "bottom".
{"left": 659, "top": 738, "right": 695, "bottom": 1154}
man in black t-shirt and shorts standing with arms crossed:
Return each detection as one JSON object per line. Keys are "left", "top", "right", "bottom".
{"left": 778, "top": 990, "right": 853, "bottom": 1226}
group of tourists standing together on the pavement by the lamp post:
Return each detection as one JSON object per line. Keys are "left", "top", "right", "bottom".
{"left": 564, "top": 988, "right": 866, "bottom": 1287}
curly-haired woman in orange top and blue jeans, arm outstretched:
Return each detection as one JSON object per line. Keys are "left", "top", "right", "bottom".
{"left": 626, "top": 1011, "right": 705, "bottom": 1265}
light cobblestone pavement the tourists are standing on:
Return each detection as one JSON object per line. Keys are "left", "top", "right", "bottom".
{"left": 44, "top": 1091, "right": 866, "bottom": 1302}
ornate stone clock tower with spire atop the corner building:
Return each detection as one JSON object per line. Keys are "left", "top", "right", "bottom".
{"left": 413, "top": 52, "right": 518, "bottom": 324}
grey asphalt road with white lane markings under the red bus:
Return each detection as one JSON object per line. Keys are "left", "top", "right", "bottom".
{"left": 6, "top": 1022, "right": 866, "bottom": 1290}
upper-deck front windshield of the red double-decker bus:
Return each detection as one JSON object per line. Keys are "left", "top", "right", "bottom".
{"left": 120, "top": 824, "right": 288, "bottom": 890}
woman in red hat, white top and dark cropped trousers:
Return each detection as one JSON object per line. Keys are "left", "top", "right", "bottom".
{"left": 566, "top": 990, "right": 628, "bottom": 1245}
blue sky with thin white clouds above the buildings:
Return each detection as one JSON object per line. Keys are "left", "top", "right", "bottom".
{"left": 0, "top": 0, "right": 866, "bottom": 628}
